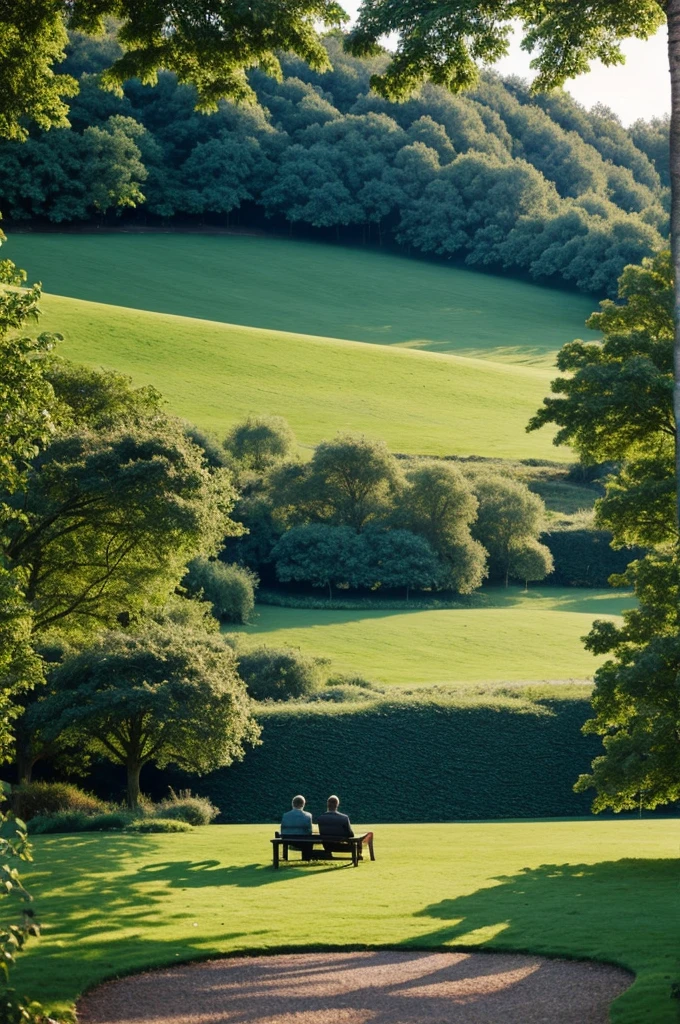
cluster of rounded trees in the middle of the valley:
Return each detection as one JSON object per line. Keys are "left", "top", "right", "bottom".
{"left": 225, "top": 419, "right": 552, "bottom": 597}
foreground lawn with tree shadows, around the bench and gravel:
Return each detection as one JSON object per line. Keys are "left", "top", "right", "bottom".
{"left": 14, "top": 823, "right": 680, "bottom": 1024}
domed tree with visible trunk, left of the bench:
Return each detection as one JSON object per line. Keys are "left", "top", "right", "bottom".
{"left": 30, "top": 624, "right": 259, "bottom": 809}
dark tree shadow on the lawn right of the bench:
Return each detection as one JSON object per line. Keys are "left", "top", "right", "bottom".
{"left": 406, "top": 858, "right": 680, "bottom": 1021}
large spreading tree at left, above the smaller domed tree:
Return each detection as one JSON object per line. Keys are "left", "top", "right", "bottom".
{"left": 0, "top": 419, "right": 237, "bottom": 633}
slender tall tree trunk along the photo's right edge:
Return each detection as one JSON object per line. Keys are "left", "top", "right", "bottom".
{"left": 666, "top": 0, "right": 680, "bottom": 544}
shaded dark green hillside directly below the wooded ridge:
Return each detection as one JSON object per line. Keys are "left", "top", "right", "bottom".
{"left": 3, "top": 232, "right": 597, "bottom": 361}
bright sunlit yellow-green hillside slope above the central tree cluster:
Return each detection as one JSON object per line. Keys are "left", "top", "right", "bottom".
{"left": 41, "top": 296, "right": 569, "bottom": 461}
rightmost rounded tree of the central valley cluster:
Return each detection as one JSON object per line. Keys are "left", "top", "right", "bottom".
{"left": 472, "top": 475, "right": 552, "bottom": 587}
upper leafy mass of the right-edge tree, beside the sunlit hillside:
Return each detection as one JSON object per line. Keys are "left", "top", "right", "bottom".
{"left": 527, "top": 252, "right": 678, "bottom": 547}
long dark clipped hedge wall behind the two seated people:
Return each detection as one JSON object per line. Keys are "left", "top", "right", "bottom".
{"left": 151, "top": 698, "right": 601, "bottom": 822}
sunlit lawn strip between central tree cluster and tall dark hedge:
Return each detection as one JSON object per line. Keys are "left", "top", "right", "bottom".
{"left": 232, "top": 587, "right": 631, "bottom": 685}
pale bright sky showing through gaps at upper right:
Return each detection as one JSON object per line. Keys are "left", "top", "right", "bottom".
{"left": 340, "top": 0, "right": 671, "bottom": 125}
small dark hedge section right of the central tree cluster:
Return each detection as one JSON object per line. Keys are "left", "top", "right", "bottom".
{"left": 541, "top": 529, "right": 645, "bottom": 587}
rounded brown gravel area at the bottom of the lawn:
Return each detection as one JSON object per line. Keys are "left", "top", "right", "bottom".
{"left": 78, "top": 950, "right": 632, "bottom": 1024}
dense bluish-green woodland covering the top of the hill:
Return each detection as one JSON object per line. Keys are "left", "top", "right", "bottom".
{"left": 0, "top": 29, "right": 670, "bottom": 294}
